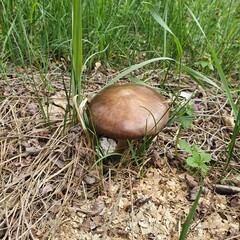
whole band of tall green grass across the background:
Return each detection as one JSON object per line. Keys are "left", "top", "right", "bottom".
{"left": 0, "top": 0, "right": 240, "bottom": 77}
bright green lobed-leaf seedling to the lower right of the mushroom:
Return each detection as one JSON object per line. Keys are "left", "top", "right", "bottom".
{"left": 178, "top": 140, "right": 211, "bottom": 176}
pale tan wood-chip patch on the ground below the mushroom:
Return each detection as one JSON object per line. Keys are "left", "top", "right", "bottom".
{"left": 55, "top": 167, "right": 239, "bottom": 239}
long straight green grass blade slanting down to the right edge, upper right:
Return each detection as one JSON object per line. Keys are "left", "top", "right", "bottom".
{"left": 187, "top": 7, "right": 237, "bottom": 118}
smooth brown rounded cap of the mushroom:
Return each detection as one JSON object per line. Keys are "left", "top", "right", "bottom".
{"left": 88, "top": 83, "right": 169, "bottom": 139}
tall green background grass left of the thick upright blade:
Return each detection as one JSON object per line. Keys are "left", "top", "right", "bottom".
{"left": 0, "top": 0, "right": 71, "bottom": 68}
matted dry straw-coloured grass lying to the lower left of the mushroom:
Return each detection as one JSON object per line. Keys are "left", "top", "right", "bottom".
{"left": 0, "top": 96, "right": 92, "bottom": 239}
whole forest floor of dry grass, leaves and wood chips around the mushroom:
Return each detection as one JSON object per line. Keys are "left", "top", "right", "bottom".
{"left": 0, "top": 62, "right": 240, "bottom": 240}
